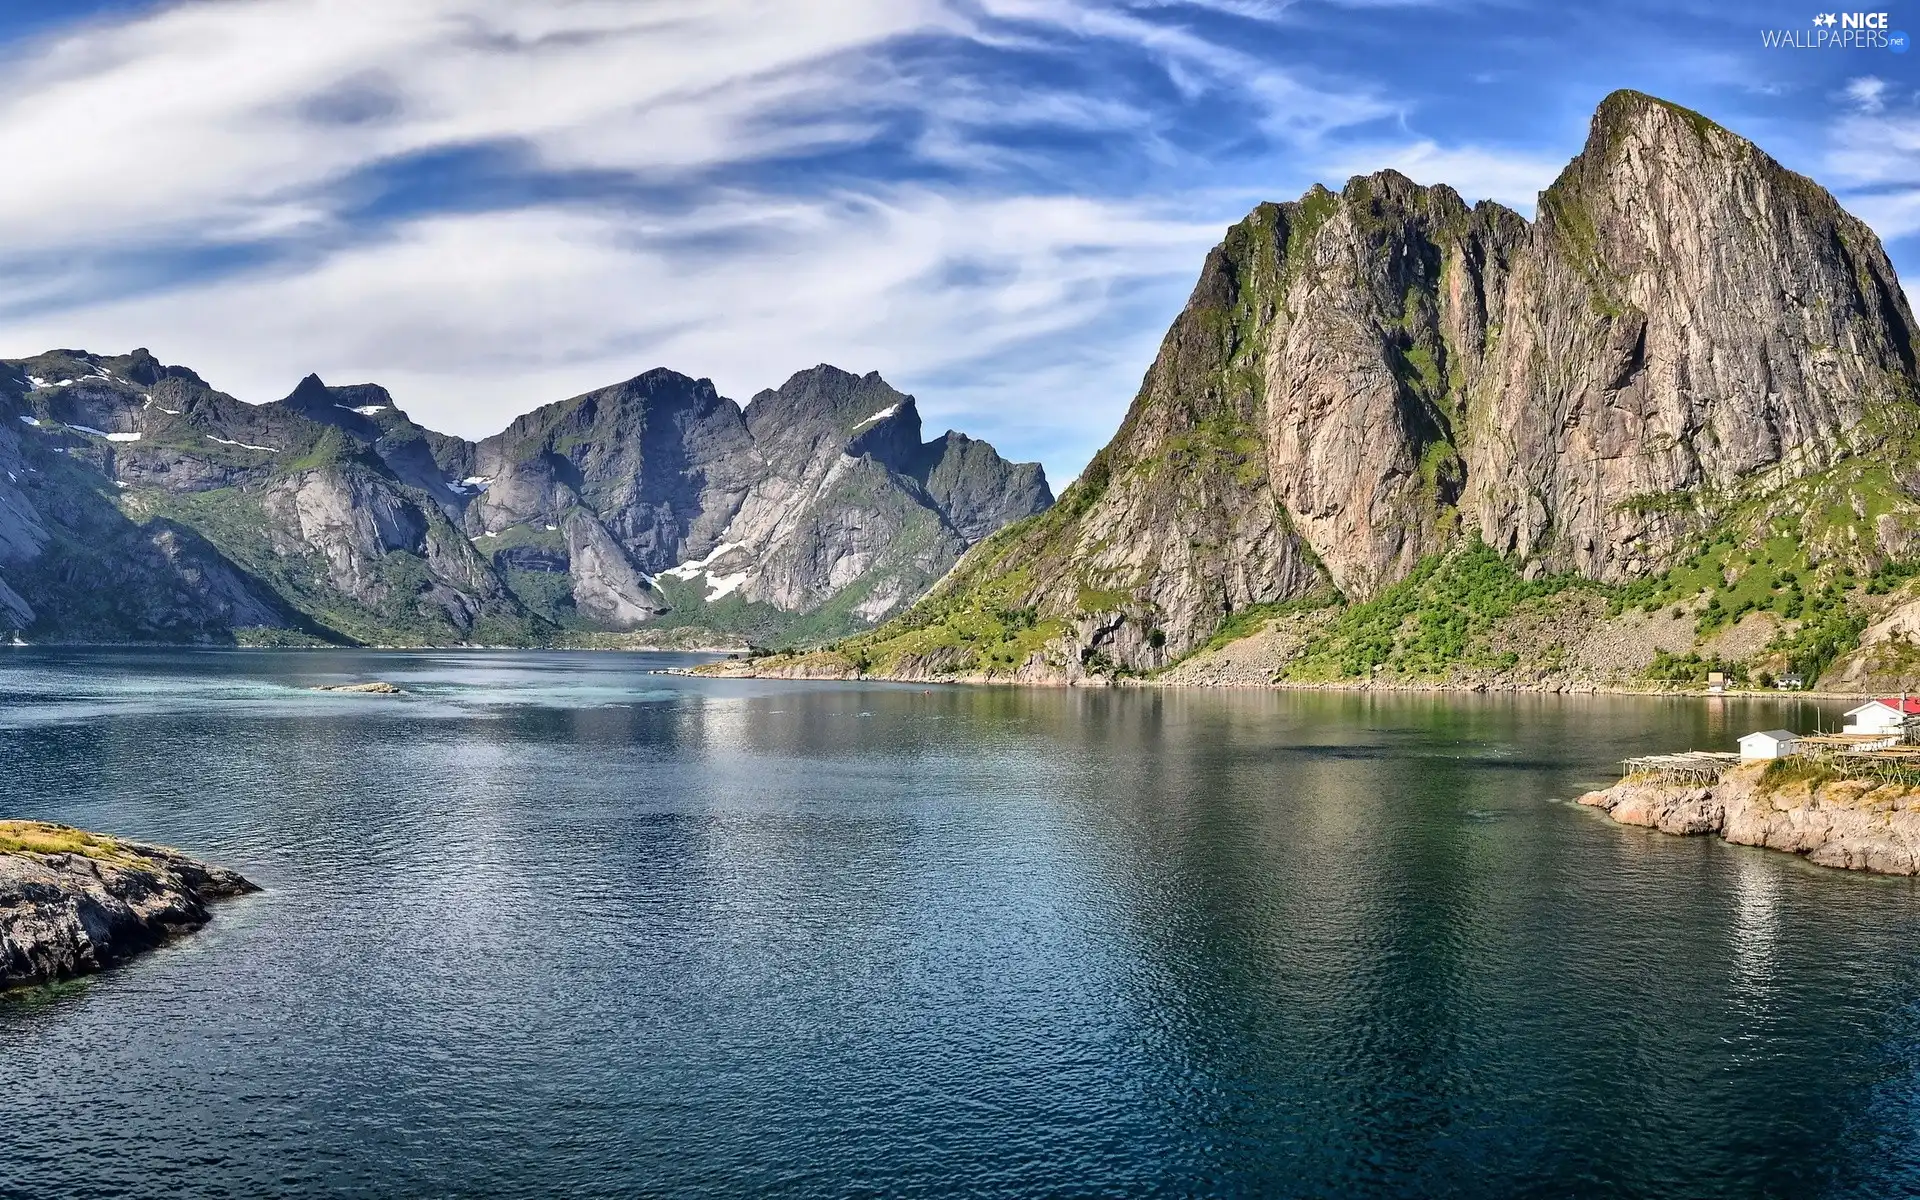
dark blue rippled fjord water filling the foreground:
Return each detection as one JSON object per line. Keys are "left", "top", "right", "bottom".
{"left": 0, "top": 649, "right": 1920, "bottom": 1196}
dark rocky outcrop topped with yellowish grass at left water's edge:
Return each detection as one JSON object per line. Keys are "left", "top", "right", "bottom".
{"left": 0, "top": 822, "right": 259, "bottom": 991}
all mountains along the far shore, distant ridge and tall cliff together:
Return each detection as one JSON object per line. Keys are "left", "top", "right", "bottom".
{"left": 22, "top": 92, "right": 1920, "bottom": 689}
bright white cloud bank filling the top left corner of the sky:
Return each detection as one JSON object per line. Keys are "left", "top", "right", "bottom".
{"left": 0, "top": 0, "right": 952, "bottom": 250}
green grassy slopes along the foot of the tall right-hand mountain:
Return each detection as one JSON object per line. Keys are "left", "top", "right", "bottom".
{"left": 756, "top": 459, "right": 1920, "bottom": 685}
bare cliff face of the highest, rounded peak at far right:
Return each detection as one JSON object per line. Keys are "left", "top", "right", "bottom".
{"left": 1469, "top": 94, "right": 1914, "bottom": 582}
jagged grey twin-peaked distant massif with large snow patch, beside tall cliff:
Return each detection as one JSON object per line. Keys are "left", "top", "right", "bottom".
{"left": 465, "top": 367, "right": 1052, "bottom": 628}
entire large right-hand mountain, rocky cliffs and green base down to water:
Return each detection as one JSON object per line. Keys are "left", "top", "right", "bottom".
{"left": 758, "top": 92, "right": 1920, "bottom": 684}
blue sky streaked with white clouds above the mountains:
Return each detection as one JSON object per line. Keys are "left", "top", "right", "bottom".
{"left": 0, "top": 0, "right": 1920, "bottom": 484}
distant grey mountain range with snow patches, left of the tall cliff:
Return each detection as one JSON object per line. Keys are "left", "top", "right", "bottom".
{"left": 0, "top": 349, "right": 1052, "bottom": 645}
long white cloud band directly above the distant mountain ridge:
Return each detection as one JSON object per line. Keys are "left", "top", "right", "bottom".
{"left": 0, "top": 190, "right": 1223, "bottom": 462}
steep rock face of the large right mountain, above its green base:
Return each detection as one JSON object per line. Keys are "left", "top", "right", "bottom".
{"left": 860, "top": 92, "right": 1920, "bottom": 678}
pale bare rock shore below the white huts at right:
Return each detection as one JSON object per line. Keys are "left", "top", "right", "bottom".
{"left": 1578, "top": 758, "right": 1920, "bottom": 876}
